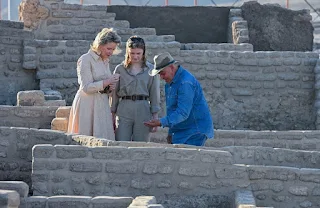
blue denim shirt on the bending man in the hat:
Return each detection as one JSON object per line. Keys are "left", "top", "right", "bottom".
{"left": 160, "top": 66, "right": 214, "bottom": 144}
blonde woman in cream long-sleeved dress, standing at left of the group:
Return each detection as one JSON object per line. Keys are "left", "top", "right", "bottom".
{"left": 68, "top": 28, "right": 121, "bottom": 140}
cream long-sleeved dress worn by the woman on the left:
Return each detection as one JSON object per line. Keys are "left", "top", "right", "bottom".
{"left": 68, "top": 50, "right": 115, "bottom": 140}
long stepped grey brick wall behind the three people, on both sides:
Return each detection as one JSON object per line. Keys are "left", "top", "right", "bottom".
{"left": 12, "top": 0, "right": 319, "bottom": 130}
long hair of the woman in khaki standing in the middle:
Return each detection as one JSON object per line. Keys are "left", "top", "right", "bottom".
{"left": 124, "top": 35, "right": 147, "bottom": 68}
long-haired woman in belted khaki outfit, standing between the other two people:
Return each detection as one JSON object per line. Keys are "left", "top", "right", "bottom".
{"left": 111, "top": 36, "right": 160, "bottom": 142}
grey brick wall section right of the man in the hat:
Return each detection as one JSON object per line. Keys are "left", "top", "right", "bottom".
{"left": 179, "top": 51, "right": 319, "bottom": 130}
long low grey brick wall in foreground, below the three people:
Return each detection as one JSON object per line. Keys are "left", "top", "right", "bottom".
{"left": 32, "top": 145, "right": 320, "bottom": 208}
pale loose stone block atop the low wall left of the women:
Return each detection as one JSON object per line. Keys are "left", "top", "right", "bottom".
{"left": 17, "top": 90, "right": 45, "bottom": 106}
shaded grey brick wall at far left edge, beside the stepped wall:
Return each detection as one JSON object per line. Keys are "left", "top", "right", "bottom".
{"left": 0, "top": 20, "right": 39, "bottom": 105}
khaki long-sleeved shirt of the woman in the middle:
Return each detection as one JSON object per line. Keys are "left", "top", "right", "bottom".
{"left": 111, "top": 62, "right": 160, "bottom": 113}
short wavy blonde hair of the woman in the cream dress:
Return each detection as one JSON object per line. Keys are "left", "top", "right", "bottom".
{"left": 90, "top": 28, "right": 121, "bottom": 54}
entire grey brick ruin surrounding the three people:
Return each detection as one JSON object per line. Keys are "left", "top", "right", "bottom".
{"left": 0, "top": 0, "right": 320, "bottom": 208}
